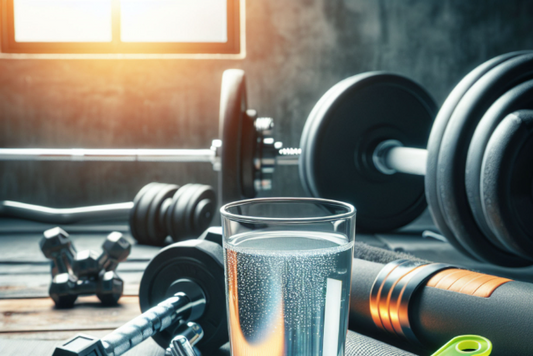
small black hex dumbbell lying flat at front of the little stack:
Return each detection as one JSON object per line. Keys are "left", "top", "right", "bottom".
{"left": 49, "top": 271, "right": 124, "bottom": 308}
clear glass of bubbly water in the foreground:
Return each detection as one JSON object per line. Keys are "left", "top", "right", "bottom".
{"left": 221, "top": 198, "right": 355, "bottom": 356}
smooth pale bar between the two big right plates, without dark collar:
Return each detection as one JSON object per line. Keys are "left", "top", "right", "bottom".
{"left": 385, "top": 147, "right": 428, "bottom": 176}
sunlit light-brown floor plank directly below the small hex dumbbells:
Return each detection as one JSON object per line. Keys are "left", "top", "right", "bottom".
{"left": 0, "top": 296, "right": 141, "bottom": 334}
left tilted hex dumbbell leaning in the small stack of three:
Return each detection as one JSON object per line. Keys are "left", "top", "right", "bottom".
{"left": 39, "top": 227, "right": 76, "bottom": 276}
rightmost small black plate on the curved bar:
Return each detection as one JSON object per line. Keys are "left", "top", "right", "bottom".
{"left": 184, "top": 184, "right": 217, "bottom": 238}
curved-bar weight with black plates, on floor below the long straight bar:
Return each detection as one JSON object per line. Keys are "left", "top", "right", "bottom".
{"left": 0, "top": 183, "right": 216, "bottom": 246}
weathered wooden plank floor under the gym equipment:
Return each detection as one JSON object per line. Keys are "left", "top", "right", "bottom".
{"left": 0, "top": 219, "right": 533, "bottom": 356}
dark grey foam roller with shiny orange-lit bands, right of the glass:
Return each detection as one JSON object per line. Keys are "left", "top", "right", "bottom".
{"left": 350, "top": 258, "right": 533, "bottom": 356}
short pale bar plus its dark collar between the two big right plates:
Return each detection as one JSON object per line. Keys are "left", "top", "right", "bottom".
{"left": 372, "top": 140, "right": 428, "bottom": 176}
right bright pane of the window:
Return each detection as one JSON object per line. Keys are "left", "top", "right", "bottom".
{"left": 120, "top": 0, "right": 228, "bottom": 42}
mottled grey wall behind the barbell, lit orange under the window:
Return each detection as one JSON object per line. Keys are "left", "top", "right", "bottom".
{"left": 0, "top": 0, "right": 533, "bottom": 206}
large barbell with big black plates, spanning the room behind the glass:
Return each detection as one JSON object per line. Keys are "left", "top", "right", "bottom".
{"left": 0, "top": 51, "right": 533, "bottom": 267}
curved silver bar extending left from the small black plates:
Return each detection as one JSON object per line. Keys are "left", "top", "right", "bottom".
{"left": 0, "top": 200, "right": 133, "bottom": 224}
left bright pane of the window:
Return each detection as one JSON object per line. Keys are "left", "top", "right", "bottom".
{"left": 14, "top": 0, "right": 112, "bottom": 42}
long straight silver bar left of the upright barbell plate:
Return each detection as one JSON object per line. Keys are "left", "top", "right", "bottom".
{"left": 0, "top": 148, "right": 215, "bottom": 163}
